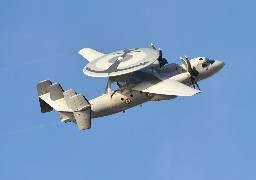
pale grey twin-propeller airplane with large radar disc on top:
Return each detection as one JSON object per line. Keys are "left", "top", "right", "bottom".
{"left": 37, "top": 43, "right": 225, "bottom": 130}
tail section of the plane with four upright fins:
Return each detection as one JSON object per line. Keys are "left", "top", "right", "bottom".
{"left": 37, "top": 80, "right": 91, "bottom": 130}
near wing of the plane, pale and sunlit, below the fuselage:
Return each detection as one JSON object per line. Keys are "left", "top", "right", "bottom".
{"left": 132, "top": 79, "right": 201, "bottom": 96}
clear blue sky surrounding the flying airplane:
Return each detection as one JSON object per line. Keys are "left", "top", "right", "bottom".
{"left": 0, "top": 0, "right": 256, "bottom": 180}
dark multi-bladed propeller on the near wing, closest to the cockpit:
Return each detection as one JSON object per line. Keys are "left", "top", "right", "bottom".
{"left": 180, "top": 55, "right": 201, "bottom": 91}
